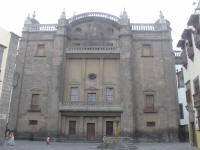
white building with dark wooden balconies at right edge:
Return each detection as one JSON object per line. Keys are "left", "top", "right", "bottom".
{"left": 176, "top": 3, "right": 200, "bottom": 147}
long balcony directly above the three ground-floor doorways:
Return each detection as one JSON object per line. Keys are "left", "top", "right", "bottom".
{"left": 59, "top": 101, "right": 122, "bottom": 112}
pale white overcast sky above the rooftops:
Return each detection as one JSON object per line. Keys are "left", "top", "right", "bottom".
{"left": 0, "top": 0, "right": 198, "bottom": 50}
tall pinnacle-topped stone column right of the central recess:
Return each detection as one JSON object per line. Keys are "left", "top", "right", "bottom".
{"left": 119, "top": 10, "right": 135, "bottom": 136}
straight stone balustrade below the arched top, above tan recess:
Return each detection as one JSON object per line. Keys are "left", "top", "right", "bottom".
{"left": 66, "top": 46, "right": 120, "bottom": 54}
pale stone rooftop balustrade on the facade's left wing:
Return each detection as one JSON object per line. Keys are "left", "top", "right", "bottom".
{"left": 23, "top": 24, "right": 57, "bottom": 32}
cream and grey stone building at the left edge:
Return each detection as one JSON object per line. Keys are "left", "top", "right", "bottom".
{"left": 0, "top": 27, "right": 19, "bottom": 143}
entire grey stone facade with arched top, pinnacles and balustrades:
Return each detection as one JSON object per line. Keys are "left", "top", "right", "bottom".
{"left": 9, "top": 11, "right": 178, "bottom": 141}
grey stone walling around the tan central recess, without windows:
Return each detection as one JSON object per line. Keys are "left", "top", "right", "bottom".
{"left": 9, "top": 12, "right": 178, "bottom": 141}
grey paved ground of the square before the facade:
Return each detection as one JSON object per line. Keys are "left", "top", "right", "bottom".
{"left": 0, "top": 140, "right": 199, "bottom": 150}
